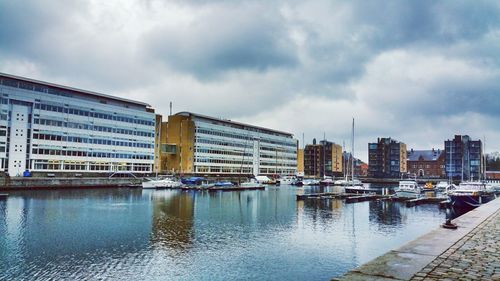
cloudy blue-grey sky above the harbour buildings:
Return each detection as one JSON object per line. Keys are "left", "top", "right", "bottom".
{"left": 0, "top": 0, "right": 500, "bottom": 161}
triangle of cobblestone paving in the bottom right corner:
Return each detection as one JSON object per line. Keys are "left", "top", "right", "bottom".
{"left": 410, "top": 208, "right": 500, "bottom": 281}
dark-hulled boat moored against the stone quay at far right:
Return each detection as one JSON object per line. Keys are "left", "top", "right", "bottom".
{"left": 448, "top": 181, "right": 495, "bottom": 208}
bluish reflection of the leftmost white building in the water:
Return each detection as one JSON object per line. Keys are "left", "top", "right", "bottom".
{"left": 0, "top": 189, "right": 151, "bottom": 272}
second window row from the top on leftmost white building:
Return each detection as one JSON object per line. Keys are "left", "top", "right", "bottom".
{"left": 35, "top": 103, "right": 155, "bottom": 126}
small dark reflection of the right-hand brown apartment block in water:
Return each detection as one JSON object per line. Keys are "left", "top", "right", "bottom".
{"left": 369, "top": 201, "right": 407, "bottom": 227}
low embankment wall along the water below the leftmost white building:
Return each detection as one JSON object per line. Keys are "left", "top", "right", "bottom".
{"left": 0, "top": 177, "right": 142, "bottom": 190}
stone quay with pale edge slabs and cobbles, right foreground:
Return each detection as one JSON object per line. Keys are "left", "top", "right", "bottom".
{"left": 332, "top": 198, "right": 500, "bottom": 281}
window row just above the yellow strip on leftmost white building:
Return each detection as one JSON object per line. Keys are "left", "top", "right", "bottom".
{"left": 32, "top": 148, "right": 154, "bottom": 160}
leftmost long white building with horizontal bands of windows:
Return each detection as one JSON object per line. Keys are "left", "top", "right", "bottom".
{"left": 0, "top": 73, "right": 155, "bottom": 176}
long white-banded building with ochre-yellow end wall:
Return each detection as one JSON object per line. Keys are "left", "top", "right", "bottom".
{"left": 161, "top": 112, "right": 298, "bottom": 175}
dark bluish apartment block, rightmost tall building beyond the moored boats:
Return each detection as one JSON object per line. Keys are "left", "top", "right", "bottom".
{"left": 444, "top": 135, "right": 483, "bottom": 180}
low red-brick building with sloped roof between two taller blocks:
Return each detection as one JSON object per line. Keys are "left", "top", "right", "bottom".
{"left": 407, "top": 148, "right": 446, "bottom": 178}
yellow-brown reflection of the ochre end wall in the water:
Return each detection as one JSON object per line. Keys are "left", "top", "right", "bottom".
{"left": 151, "top": 190, "right": 194, "bottom": 248}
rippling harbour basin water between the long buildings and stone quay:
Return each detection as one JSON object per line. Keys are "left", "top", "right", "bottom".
{"left": 0, "top": 186, "right": 446, "bottom": 280}
